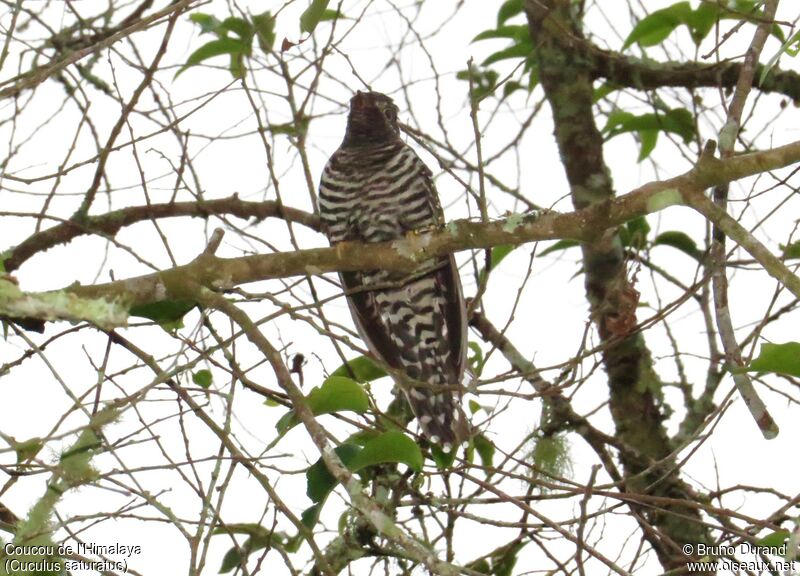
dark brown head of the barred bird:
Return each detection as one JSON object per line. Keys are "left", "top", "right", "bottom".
{"left": 344, "top": 92, "right": 400, "bottom": 146}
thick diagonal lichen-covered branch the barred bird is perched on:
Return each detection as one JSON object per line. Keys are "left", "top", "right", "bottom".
{"left": 0, "top": 137, "right": 800, "bottom": 330}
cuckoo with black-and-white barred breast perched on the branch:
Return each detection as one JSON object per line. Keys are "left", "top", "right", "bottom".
{"left": 318, "top": 91, "right": 471, "bottom": 452}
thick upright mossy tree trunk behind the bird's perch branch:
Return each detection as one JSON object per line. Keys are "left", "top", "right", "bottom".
{"left": 524, "top": 0, "right": 710, "bottom": 571}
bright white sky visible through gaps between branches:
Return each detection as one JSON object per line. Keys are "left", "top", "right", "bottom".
{"left": 0, "top": 0, "right": 800, "bottom": 574}
